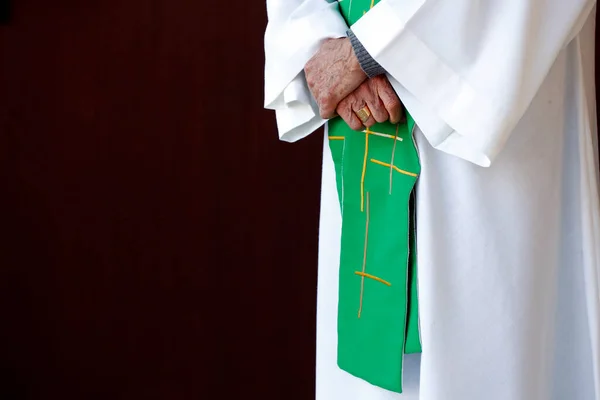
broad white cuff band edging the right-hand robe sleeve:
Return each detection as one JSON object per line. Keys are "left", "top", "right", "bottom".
{"left": 352, "top": 0, "right": 506, "bottom": 167}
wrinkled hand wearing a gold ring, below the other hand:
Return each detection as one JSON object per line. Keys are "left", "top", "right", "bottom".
{"left": 336, "top": 75, "right": 404, "bottom": 131}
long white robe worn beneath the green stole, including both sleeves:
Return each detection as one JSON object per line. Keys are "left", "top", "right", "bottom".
{"left": 265, "top": 0, "right": 600, "bottom": 400}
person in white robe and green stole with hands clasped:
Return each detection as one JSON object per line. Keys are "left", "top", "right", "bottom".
{"left": 265, "top": 0, "right": 600, "bottom": 400}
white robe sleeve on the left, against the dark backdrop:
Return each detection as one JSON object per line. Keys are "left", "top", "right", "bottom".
{"left": 265, "top": 0, "right": 348, "bottom": 142}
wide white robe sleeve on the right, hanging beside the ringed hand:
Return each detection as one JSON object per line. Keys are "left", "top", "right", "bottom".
{"left": 351, "top": 0, "right": 596, "bottom": 167}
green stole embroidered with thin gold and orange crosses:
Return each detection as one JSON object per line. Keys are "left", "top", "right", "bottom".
{"left": 329, "top": 0, "right": 421, "bottom": 392}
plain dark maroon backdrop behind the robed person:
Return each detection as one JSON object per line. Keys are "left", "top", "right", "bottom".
{"left": 0, "top": 0, "right": 596, "bottom": 400}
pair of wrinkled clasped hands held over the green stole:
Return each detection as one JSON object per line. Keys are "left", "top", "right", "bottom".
{"left": 304, "top": 38, "right": 402, "bottom": 130}
